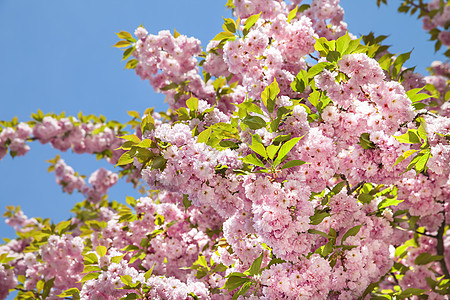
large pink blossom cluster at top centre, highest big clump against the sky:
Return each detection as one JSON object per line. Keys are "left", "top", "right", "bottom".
{"left": 221, "top": 14, "right": 315, "bottom": 98}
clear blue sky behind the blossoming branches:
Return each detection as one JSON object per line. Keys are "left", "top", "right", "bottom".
{"left": 0, "top": 0, "right": 444, "bottom": 244}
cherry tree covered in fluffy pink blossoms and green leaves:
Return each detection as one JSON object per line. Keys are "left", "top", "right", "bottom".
{"left": 0, "top": 0, "right": 450, "bottom": 299}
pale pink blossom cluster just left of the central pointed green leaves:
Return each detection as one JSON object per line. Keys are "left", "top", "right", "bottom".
{"left": 142, "top": 123, "right": 243, "bottom": 216}
